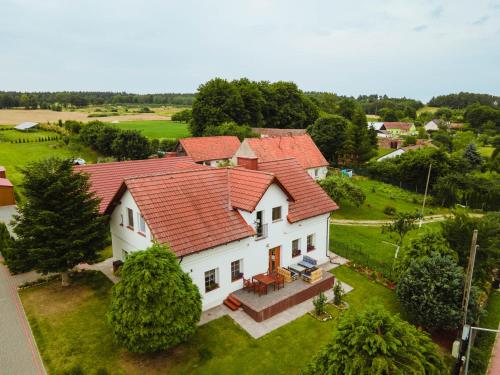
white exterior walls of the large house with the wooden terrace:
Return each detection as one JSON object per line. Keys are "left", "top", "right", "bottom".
{"left": 111, "top": 184, "right": 329, "bottom": 310}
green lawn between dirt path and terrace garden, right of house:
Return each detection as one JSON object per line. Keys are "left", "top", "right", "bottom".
{"left": 330, "top": 223, "right": 441, "bottom": 278}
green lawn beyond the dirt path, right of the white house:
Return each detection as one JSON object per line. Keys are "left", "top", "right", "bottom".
{"left": 333, "top": 176, "right": 449, "bottom": 220}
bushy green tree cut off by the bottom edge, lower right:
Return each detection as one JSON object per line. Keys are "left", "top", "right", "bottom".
{"left": 306, "top": 307, "right": 448, "bottom": 375}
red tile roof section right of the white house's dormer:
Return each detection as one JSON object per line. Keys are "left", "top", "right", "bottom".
{"left": 259, "top": 158, "right": 338, "bottom": 223}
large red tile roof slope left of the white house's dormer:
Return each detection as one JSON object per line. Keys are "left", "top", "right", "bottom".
{"left": 117, "top": 168, "right": 268, "bottom": 256}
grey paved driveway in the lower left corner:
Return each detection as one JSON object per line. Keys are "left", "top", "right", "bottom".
{"left": 0, "top": 256, "right": 45, "bottom": 375}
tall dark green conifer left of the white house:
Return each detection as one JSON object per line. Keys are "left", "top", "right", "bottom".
{"left": 14, "top": 158, "right": 108, "bottom": 285}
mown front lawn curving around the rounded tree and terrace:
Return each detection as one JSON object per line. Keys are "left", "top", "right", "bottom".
{"left": 20, "top": 267, "right": 422, "bottom": 374}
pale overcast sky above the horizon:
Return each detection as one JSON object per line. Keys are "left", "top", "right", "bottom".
{"left": 0, "top": 0, "right": 500, "bottom": 101}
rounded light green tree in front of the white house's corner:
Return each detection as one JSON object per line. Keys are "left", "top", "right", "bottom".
{"left": 108, "top": 243, "right": 201, "bottom": 353}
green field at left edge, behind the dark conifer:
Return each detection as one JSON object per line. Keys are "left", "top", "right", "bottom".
{"left": 0, "top": 130, "right": 99, "bottom": 193}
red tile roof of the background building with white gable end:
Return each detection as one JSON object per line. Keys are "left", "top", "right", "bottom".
{"left": 243, "top": 134, "right": 328, "bottom": 169}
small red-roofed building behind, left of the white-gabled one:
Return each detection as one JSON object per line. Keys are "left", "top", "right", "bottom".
{"left": 177, "top": 136, "right": 241, "bottom": 167}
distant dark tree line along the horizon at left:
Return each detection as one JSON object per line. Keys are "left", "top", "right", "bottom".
{"left": 0, "top": 91, "right": 194, "bottom": 109}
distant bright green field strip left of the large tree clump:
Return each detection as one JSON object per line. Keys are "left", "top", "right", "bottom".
{"left": 115, "top": 120, "right": 191, "bottom": 139}
